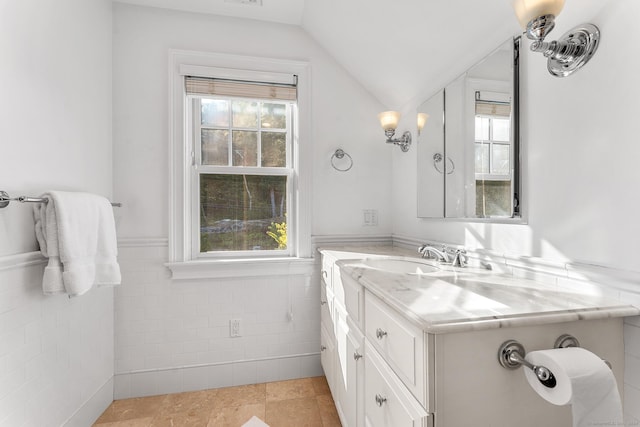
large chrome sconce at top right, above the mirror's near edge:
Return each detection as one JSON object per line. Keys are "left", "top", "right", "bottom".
{"left": 512, "top": 0, "right": 600, "bottom": 77}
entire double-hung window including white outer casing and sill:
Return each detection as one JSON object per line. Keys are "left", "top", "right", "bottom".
{"left": 167, "top": 51, "right": 312, "bottom": 272}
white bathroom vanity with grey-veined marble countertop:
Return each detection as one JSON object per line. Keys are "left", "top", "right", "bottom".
{"left": 320, "top": 248, "right": 640, "bottom": 427}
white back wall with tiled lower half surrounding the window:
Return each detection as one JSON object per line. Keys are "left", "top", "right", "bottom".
{"left": 113, "top": 3, "right": 390, "bottom": 397}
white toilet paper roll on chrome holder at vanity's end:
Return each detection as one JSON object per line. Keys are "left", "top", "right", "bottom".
{"left": 524, "top": 347, "right": 624, "bottom": 427}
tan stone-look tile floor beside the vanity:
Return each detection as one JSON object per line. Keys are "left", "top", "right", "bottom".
{"left": 94, "top": 377, "right": 341, "bottom": 427}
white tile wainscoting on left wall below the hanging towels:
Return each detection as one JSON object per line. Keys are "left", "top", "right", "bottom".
{"left": 0, "top": 252, "right": 114, "bottom": 427}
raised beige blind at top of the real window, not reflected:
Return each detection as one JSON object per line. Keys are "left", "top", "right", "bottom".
{"left": 185, "top": 76, "right": 297, "bottom": 101}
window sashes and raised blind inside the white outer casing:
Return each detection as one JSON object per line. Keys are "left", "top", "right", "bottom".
{"left": 185, "top": 76, "right": 296, "bottom": 257}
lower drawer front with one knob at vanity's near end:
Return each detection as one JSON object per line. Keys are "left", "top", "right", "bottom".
{"left": 364, "top": 340, "right": 428, "bottom": 427}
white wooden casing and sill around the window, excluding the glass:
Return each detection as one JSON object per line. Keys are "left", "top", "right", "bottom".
{"left": 166, "top": 50, "right": 312, "bottom": 279}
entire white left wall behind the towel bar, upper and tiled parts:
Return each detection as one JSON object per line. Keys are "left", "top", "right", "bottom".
{"left": 0, "top": 0, "right": 114, "bottom": 426}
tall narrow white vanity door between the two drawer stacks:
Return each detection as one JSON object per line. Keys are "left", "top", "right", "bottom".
{"left": 336, "top": 310, "right": 364, "bottom": 427}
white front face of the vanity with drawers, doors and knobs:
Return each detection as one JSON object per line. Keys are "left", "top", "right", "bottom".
{"left": 321, "top": 253, "right": 431, "bottom": 427}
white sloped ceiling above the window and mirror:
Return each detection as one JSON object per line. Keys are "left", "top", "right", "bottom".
{"left": 117, "top": 0, "right": 524, "bottom": 109}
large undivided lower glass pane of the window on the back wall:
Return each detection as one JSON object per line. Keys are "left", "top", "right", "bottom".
{"left": 200, "top": 174, "right": 287, "bottom": 252}
